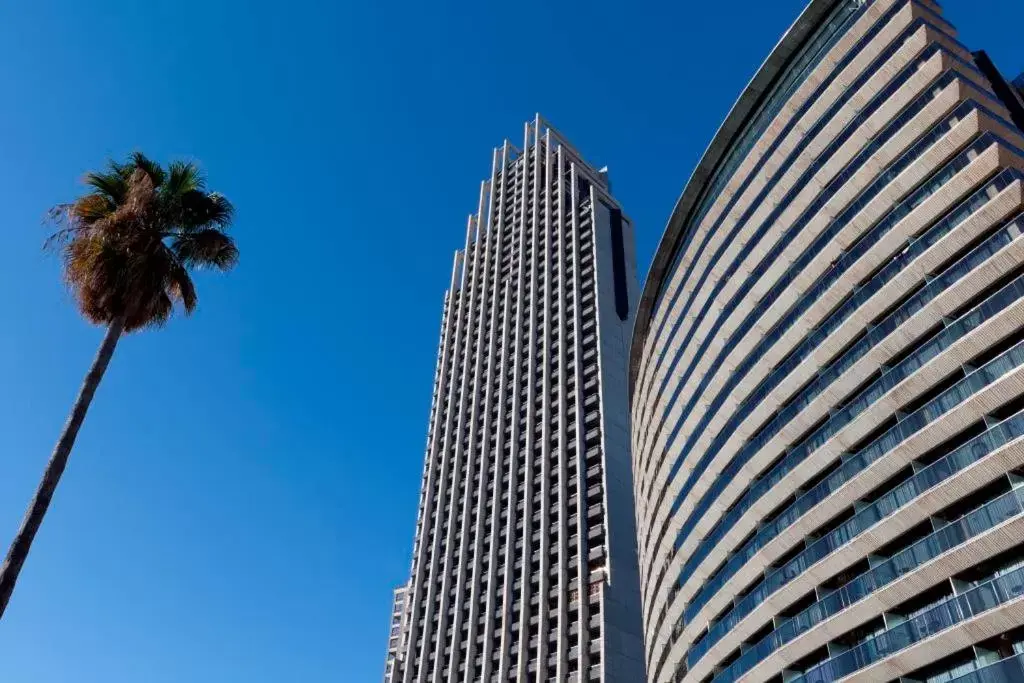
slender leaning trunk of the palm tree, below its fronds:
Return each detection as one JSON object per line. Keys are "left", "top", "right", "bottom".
{"left": 0, "top": 317, "right": 125, "bottom": 618}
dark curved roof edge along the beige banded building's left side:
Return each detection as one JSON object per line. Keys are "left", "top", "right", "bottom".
{"left": 630, "top": 0, "right": 843, "bottom": 396}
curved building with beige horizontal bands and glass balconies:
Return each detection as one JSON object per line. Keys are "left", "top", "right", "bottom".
{"left": 630, "top": 0, "right": 1024, "bottom": 683}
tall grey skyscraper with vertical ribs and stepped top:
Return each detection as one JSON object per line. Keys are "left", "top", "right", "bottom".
{"left": 387, "top": 116, "right": 644, "bottom": 683}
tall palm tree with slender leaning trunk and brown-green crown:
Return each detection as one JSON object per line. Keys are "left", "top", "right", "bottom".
{"left": 0, "top": 153, "right": 239, "bottom": 617}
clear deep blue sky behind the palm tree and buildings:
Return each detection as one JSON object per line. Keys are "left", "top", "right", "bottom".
{"left": 0, "top": 0, "right": 1024, "bottom": 683}
